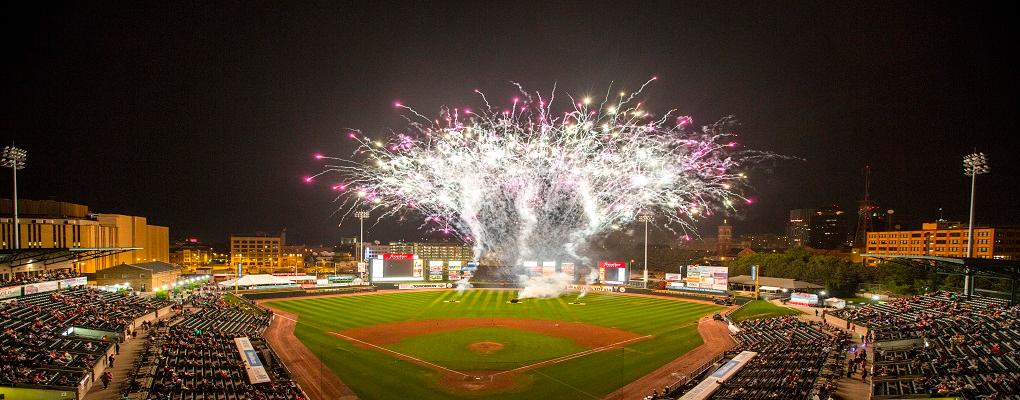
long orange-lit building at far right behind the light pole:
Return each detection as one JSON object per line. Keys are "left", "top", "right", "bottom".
{"left": 867, "top": 220, "right": 1020, "bottom": 259}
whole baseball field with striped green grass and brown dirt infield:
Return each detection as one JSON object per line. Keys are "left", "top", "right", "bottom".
{"left": 264, "top": 290, "right": 721, "bottom": 399}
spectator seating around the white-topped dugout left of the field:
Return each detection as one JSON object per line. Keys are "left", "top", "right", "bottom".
{"left": 128, "top": 292, "right": 304, "bottom": 400}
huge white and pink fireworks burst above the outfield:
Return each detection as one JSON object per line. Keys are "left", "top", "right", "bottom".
{"left": 306, "top": 79, "right": 768, "bottom": 265}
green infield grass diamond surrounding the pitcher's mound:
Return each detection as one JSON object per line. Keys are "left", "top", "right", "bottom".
{"left": 386, "top": 328, "right": 588, "bottom": 370}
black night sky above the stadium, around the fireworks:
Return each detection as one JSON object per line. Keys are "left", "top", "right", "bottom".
{"left": 0, "top": 2, "right": 1020, "bottom": 244}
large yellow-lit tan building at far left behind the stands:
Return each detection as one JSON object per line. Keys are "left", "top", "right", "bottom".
{"left": 0, "top": 199, "right": 169, "bottom": 273}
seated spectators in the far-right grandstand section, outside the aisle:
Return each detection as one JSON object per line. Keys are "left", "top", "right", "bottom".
{"left": 840, "top": 292, "right": 1020, "bottom": 399}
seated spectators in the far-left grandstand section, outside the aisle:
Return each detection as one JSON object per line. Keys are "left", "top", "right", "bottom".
{"left": 0, "top": 288, "right": 165, "bottom": 390}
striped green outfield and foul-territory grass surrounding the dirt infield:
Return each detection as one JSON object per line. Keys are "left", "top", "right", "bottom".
{"left": 268, "top": 290, "right": 722, "bottom": 399}
